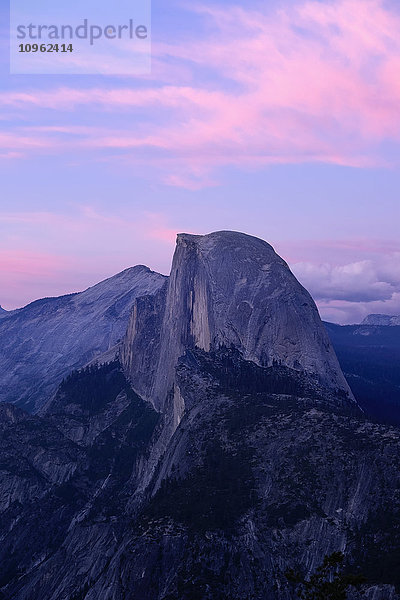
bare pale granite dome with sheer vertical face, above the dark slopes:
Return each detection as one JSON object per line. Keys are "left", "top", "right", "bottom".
{"left": 122, "top": 231, "right": 351, "bottom": 409}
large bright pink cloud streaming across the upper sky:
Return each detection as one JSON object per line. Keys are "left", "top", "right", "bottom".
{"left": 0, "top": 0, "right": 400, "bottom": 189}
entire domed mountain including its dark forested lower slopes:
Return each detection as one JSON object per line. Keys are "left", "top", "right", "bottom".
{"left": 0, "top": 232, "right": 400, "bottom": 600}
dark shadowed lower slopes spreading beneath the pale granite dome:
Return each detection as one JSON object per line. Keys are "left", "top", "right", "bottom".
{"left": 0, "top": 348, "right": 400, "bottom": 600}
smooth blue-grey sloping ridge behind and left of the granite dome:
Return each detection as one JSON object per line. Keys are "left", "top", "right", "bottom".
{"left": 0, "top": 266, "right": 165, "bottom": 411}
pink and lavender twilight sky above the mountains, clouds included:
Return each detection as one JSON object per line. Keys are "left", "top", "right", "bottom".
{"left": 0, "top": 0, "right": 400, "bottom": 324}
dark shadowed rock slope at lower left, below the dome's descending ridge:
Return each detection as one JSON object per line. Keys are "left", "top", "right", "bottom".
{"left": 0, "top": 363, "right": 158, "bottom": 600}
